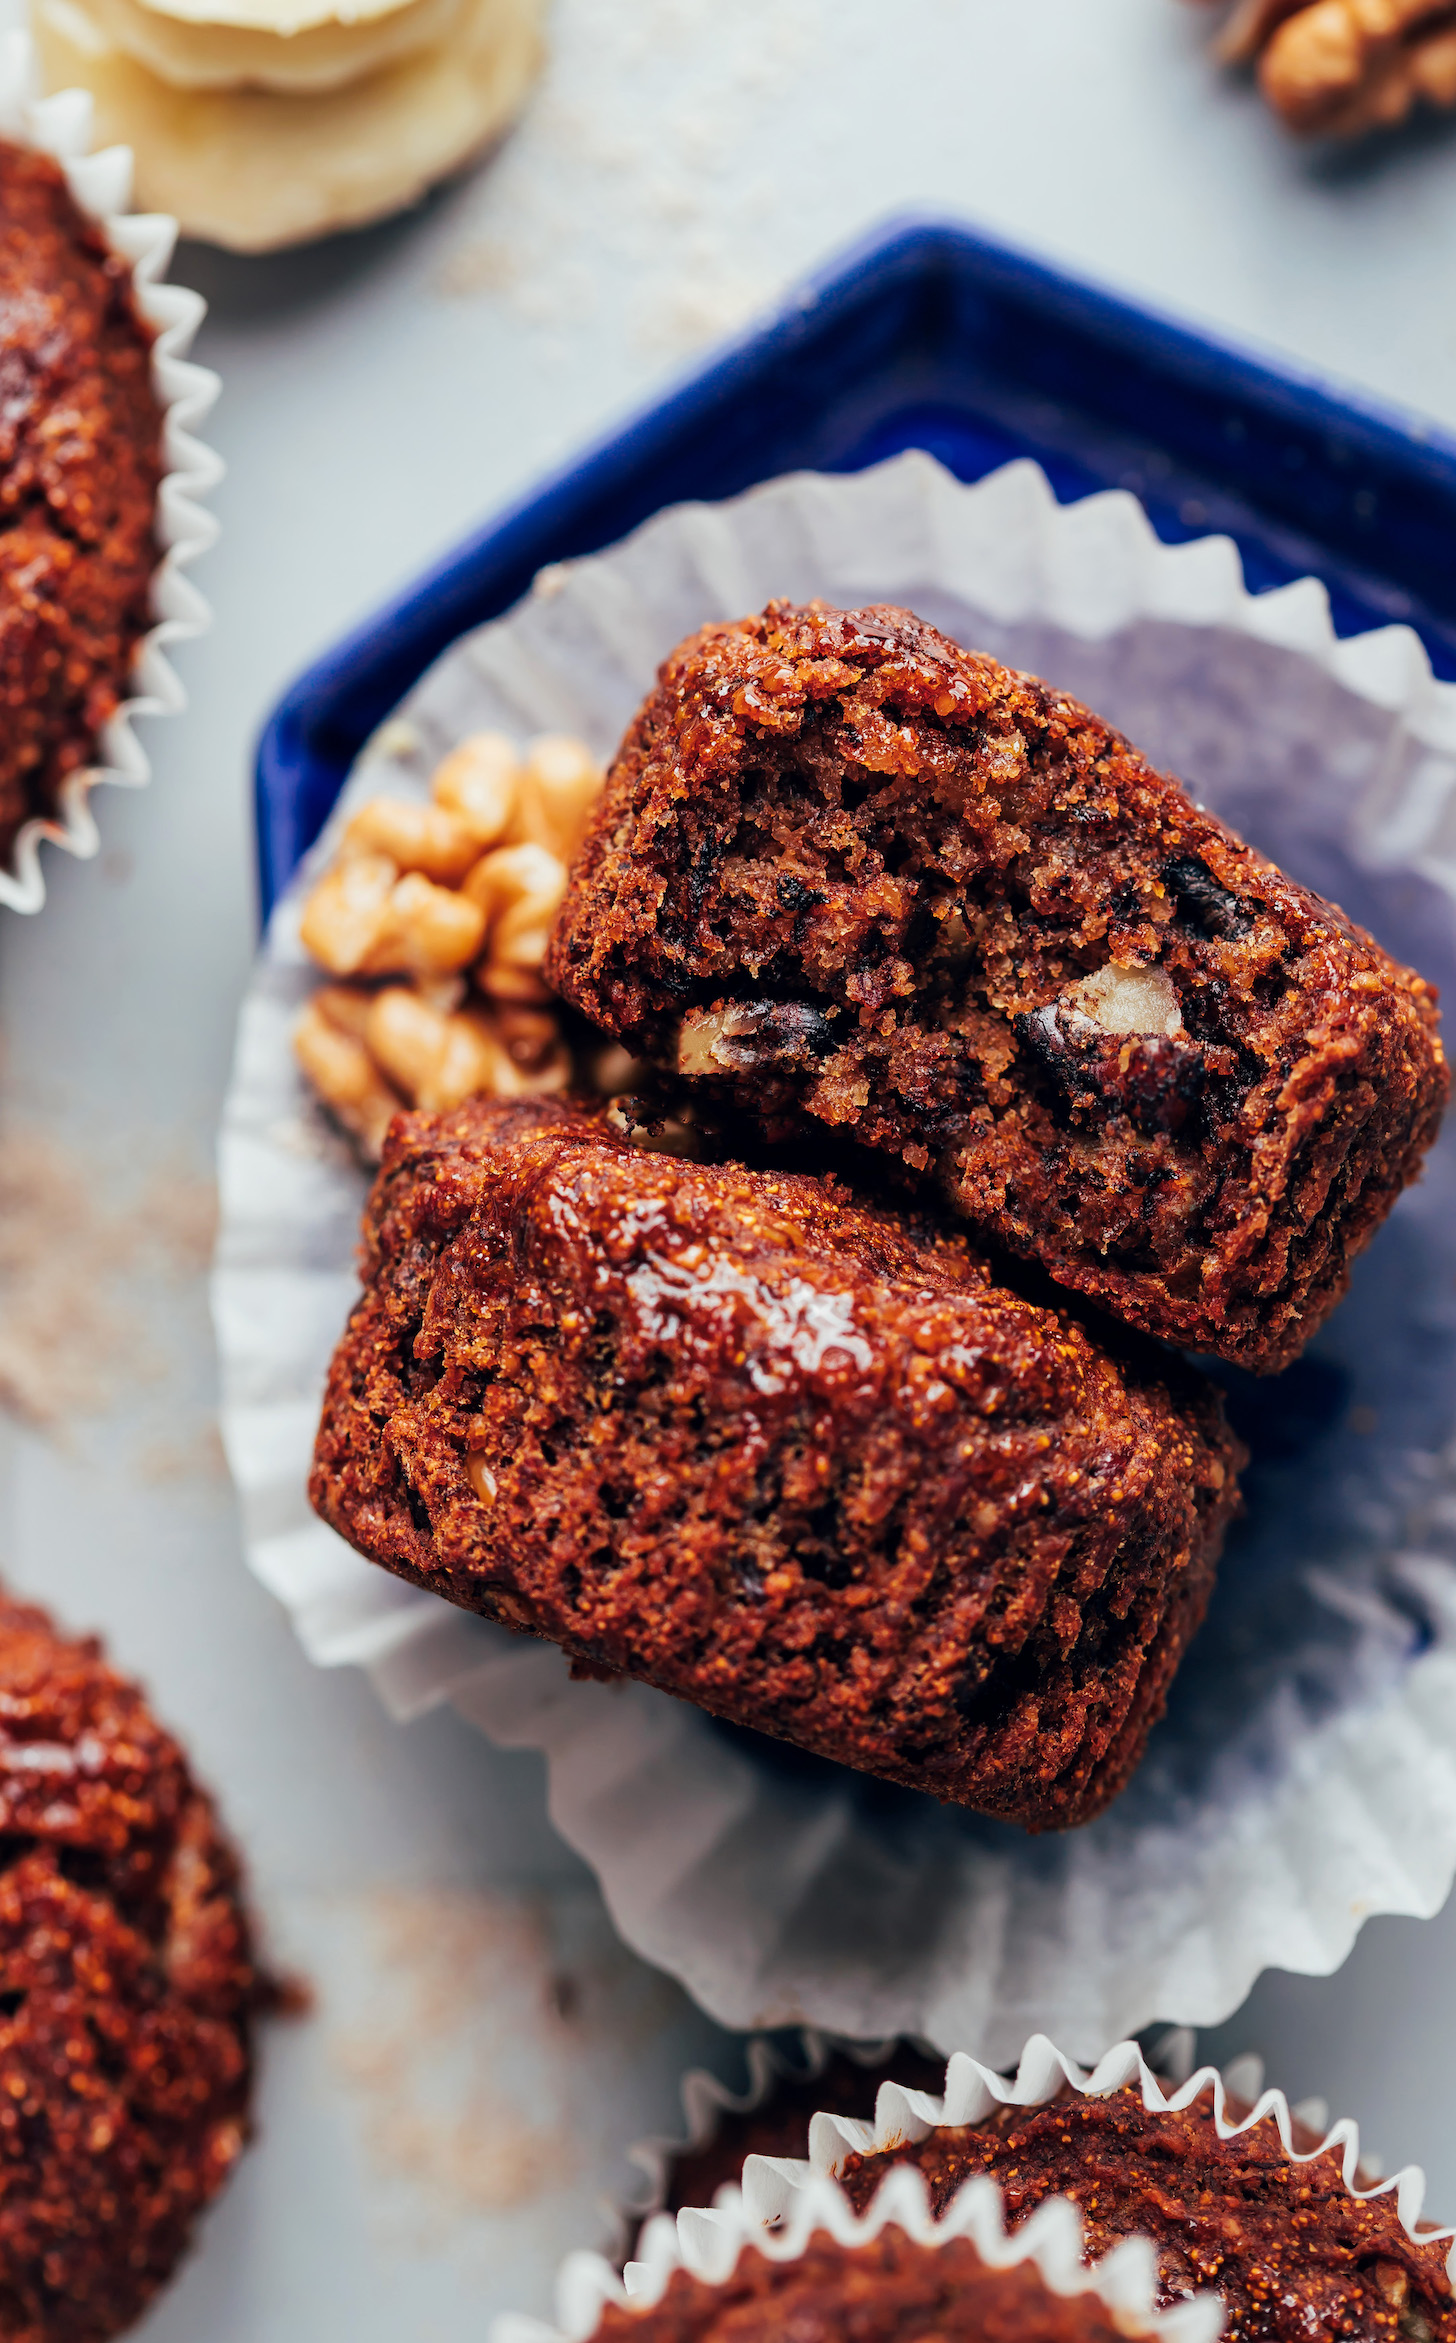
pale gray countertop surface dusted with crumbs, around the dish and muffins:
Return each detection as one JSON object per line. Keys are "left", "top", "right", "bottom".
{"left": 0, "top": 0, "right": 1456, "bottom": 2343}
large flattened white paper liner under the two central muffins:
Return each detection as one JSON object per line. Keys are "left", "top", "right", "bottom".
{"left": 213, "top": 455, "right": 1456, "bottom": 2064}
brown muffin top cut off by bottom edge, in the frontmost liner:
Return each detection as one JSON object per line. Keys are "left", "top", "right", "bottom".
{"left": 596, "top": 2228, "right": 1125, "bottom": 2343}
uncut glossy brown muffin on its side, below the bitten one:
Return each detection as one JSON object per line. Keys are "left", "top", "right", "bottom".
{"left": 309, "top": 1099, "right": 1240, "bottom": 1828}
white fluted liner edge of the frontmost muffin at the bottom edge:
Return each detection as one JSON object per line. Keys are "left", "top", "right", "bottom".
{"left": 490, "top": 2158, "right": 1224, "bottom": 2343}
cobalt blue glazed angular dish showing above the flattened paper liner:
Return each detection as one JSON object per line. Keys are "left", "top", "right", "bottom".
{"left": 256, "top": 216, "right": 1456, "bottom": 918}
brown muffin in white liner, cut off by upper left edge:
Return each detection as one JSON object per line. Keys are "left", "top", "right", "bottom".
{"left": 0, "top": 141, "right": 162, "bottom": 867}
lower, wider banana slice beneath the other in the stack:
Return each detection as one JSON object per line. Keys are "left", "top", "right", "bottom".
{"left": 35, "top": 0, "right": 544, "bottom": 253}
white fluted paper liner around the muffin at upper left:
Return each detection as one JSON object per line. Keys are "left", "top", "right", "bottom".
{"left": 0, "top": 30, "right": 223, "bottom": 911}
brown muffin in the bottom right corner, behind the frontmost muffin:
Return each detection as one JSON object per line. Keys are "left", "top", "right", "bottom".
{"left": 842, "top": 2085, "right": 1456, "bottom": 2343}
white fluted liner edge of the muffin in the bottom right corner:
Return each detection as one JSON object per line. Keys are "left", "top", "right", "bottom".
{"left": 741, "top": 2034, "right": 1456, "bottom": 2282}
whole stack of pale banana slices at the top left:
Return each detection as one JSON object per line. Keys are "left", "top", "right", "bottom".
{"left": 33, "top": 0, "right": 544, "bottom": 253}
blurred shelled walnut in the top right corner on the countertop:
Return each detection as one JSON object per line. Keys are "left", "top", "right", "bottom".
{"left": 1186, "top": 0, "right": 1456, "bottom": 138}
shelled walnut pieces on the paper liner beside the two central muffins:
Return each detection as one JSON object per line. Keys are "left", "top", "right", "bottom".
{"left": 293, "top": 733, "right": 609, "bottom": 1160}
